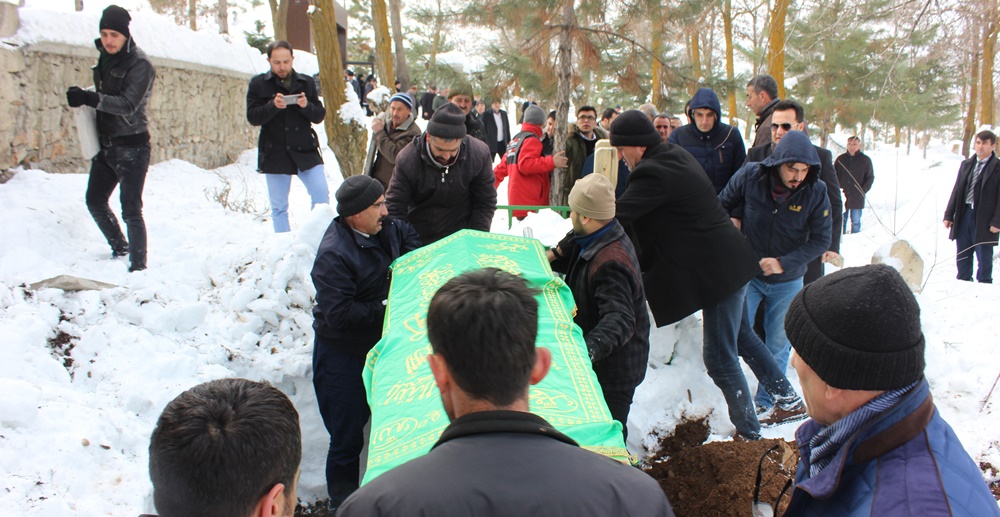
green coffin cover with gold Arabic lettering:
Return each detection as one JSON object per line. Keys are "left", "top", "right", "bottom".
{"left": 363, "top": 230, "right": 628, "bottom": 483}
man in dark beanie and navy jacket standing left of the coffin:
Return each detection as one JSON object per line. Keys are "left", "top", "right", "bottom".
{"left": 312, "top": 176, "right": 420, "bottom": 508}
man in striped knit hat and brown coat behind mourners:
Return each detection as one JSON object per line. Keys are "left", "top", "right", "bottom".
{"left": 364, "top": 93, "right": 420, "bottom": 189}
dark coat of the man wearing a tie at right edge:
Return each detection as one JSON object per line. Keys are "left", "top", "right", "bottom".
{"left": 944, "top": 155, "right": 1000, "bottom": 244}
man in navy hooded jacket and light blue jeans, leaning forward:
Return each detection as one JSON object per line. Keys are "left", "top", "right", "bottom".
{"left": 719, "top": 131, "right": 833, "bottom": 425}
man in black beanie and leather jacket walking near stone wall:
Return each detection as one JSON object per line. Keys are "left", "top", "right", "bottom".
{"left": 66, "top": 5, "right": 156, "bottom": 271}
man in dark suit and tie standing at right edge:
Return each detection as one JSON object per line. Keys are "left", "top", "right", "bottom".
{"left": 944, "top": 131, "right": 1000, "bottom": 284}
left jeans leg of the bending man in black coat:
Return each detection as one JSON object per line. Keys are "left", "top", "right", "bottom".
{"left": 702, "top": 286, "right": 760, "bottom": 439}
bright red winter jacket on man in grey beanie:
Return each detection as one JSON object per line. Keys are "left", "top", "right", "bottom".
{"left": 493, "top": 124, "right": 555, "bottom": 218}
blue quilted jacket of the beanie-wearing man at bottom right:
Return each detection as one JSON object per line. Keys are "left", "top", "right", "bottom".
{"left": 784, "top": 380, "right": 1000, "bottom": 517}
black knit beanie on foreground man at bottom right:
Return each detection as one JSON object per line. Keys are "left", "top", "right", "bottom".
{"left": 785, "top": 264, "right": 924, "bottom": 391}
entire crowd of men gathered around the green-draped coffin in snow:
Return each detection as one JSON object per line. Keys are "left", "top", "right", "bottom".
{"left": 66, "top": 11, "right": 1000, "bottom": 516}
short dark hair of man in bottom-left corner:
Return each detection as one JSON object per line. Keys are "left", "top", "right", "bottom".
{"left": 149, "top": 379, "right": 302, "bottom": 517}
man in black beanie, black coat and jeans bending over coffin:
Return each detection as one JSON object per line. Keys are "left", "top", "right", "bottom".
{"left": 611, "top": 110, "right": 802, "bottom": 440}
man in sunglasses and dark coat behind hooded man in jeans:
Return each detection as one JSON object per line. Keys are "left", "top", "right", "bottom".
{"left": 747, "top": 100, "right": 844, "bottom": 284}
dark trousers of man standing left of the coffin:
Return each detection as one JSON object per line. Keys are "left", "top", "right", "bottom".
{"left": 313, "top": 338, "right": 371, "bottom": 508}
